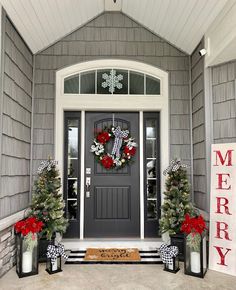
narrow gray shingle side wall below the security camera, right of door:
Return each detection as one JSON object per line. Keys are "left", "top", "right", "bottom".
{"left": 191, "top": 41, "right": 207, "bottom": 210}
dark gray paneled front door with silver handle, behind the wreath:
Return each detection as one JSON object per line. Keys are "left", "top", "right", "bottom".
{"left": 84, "top": 112, "right": 140, "bottom": 238}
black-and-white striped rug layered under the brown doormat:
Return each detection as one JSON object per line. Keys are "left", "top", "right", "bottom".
{"left": 65, "top": 248, "right": 162, "bottom": 264}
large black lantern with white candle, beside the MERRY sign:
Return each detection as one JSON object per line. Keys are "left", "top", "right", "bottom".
{"left": 184, "top": 232, "right": 207, "bottom": 278}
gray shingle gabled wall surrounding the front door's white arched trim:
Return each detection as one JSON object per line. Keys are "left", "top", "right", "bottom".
{"left": 33, "top": 12, "right": 190, "bottom": 177}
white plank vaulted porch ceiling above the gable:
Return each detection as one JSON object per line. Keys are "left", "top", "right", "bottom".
{"left": 0, "top": 0, "right": 228, "bottom": 54}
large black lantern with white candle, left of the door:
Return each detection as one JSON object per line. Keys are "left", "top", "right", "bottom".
{"left": 16, "top": 233, "right": 38, "bottom": 278}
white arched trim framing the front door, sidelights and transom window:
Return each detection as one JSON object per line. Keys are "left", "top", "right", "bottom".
{"left": 54, "top": 59, "right": 170, "bottom": 239}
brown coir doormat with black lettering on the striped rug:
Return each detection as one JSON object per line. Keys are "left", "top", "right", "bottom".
{"left": 84, "top": 248, "right": 141, "bottom": 262}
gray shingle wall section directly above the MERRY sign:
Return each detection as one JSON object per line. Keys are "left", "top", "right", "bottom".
{"left": 212, "top": 61, "right": 236, "bottom": 143}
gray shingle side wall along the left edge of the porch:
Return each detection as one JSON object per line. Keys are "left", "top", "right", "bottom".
{"left": 0, "top": 13, "right": 33, "bottom": 219}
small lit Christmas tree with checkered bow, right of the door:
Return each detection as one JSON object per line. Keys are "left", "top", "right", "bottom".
{"left": 159, "top": 159, "right": 193, "bottom": 234}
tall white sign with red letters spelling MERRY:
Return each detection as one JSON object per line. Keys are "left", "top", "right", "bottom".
{"left": 209, "top": 143, "right": 236, "bottom": 276}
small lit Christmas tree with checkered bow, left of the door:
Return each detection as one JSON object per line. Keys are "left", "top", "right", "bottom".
{"left": 31, "top": 158, "right": 67, "bottom": 240}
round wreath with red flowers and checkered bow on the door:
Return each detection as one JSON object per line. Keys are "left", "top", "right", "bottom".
{"left": 90, "top": 126, "right": 137, "bottom": 169}
